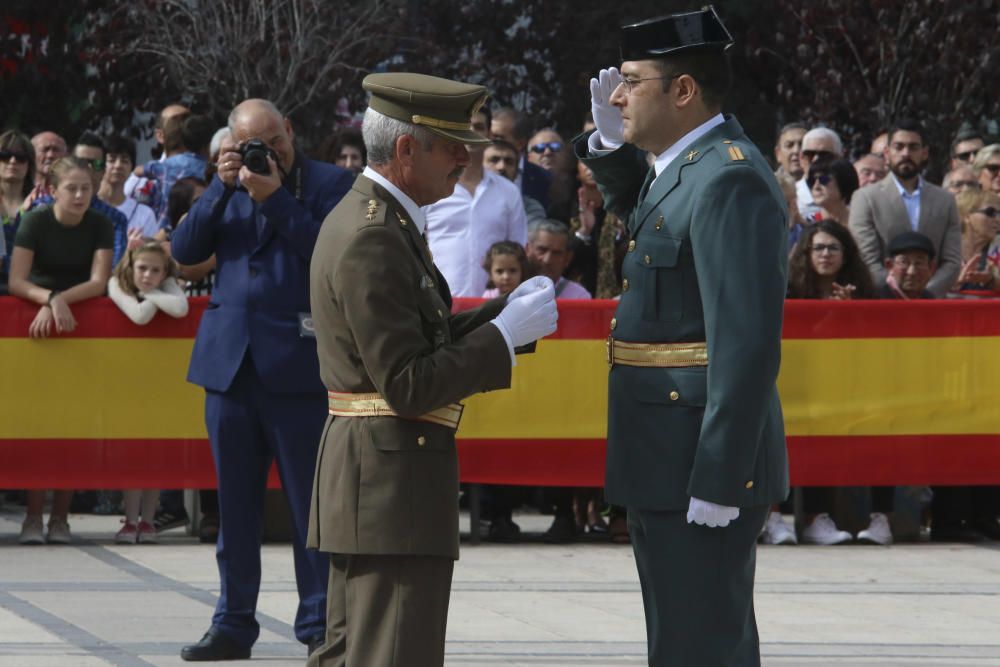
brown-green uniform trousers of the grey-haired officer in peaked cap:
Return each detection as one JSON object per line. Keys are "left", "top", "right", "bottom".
{"left": 306, "top": 554, "right": 455, "bottom": 667}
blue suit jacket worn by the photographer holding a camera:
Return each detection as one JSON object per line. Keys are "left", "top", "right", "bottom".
{"left": 172, "top": 155, "right": 354, "bottom": 393}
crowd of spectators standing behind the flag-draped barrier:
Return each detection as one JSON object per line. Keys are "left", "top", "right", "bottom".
{"left": 0, "top": 98, "right": 1000, "bottom": 544}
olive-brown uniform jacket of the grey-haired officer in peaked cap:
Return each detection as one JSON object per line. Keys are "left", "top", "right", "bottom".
{"left": 307, "top": 176, "right": 511, "bottom": 558}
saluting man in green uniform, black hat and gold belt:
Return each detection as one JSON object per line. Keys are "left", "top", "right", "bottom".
{"left": 575, "top": 7, "right": 788, "bottom": 667}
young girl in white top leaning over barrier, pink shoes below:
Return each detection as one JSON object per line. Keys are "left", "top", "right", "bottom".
{"left": 108, "top": 238, "right": 188, "bottom": 544}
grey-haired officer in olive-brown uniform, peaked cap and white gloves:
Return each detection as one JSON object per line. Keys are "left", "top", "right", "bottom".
{"left": 309, "top": 73, "right": 557, "bottom": 667}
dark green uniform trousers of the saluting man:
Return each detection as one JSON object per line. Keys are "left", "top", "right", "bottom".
{"left": 628, "top": 506, "right": 768, "bottom": 667}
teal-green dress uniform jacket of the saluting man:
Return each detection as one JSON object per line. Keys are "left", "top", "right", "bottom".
{"left": 576, "top": 117, "right": 788, "bottom": 511}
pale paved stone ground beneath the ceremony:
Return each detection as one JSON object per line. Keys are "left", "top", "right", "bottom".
{"left": 0, "top": 505, "right": 1000, "bottom": 667}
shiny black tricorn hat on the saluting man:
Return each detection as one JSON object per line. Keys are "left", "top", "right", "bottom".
{"left": 621, "top": 5, "right": 733, "bottom": 61}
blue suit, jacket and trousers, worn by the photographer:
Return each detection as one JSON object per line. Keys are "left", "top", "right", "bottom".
{"left": 173, "top": 155, "right": 354, "bottom": 646}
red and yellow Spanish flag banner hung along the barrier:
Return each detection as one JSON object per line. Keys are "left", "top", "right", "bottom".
{"left": 0, "top": 298, "right": 1000, "bottom": 488}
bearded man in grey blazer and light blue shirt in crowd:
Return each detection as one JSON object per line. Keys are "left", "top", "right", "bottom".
{"left": 848, "top": 120, "right": 962, "bottom": 297}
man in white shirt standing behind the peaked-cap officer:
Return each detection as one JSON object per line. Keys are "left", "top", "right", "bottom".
{"left": 423, "top": 108, "right": 528, "bottom": 297}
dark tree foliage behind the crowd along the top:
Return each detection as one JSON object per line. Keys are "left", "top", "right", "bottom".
{"left": 0, "top": 0, "right": 1000, "bottom": 175}
